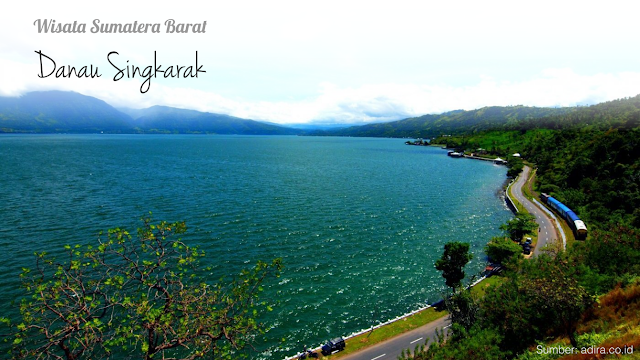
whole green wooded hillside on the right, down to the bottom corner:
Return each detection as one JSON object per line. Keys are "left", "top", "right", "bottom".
{"left": 403, "top": 97, "right": 640, "bottom": 360}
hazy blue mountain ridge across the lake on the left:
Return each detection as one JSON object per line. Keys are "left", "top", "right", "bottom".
{"left": 0, "top": 91, "right": 303, "bottom": 135}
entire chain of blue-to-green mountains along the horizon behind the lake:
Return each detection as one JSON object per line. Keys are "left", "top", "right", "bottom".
{"left": 0, "top": 91, "right": 640, "bottom": 138}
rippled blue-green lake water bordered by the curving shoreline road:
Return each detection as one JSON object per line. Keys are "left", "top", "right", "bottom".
{"left": 0, "top": 135, "right": 510, "bottom": 359}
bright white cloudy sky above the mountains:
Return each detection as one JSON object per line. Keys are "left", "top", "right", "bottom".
{"left": 0, "top": 0, "right": 640, "bottom": 124}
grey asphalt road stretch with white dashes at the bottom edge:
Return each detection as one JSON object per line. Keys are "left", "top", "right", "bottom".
{"left": 341, "top": 316, "right": 449, "bottom": 360}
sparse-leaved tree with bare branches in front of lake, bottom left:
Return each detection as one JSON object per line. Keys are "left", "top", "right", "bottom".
{"left": 4, "top": 219, "right": 281, "bottom": 360}
